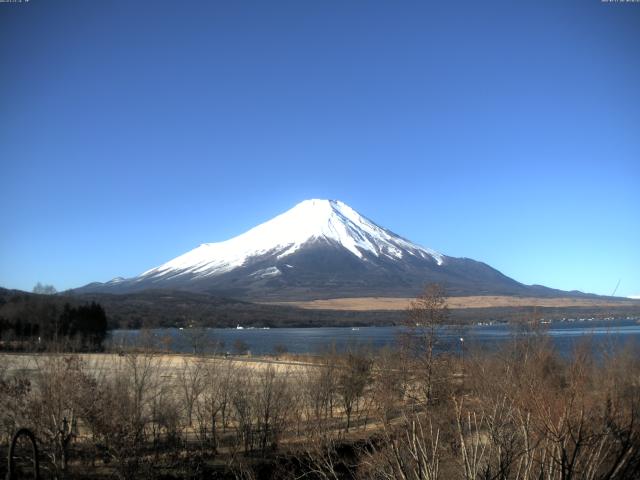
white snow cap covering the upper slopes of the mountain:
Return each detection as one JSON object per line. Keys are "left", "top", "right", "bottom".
{"left": 138, "top": 199, "right": 443, "bottom": 281}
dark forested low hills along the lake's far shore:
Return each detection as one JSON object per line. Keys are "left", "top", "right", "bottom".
{"left": 0, "top": 289, "right": 640, "bottom": 338}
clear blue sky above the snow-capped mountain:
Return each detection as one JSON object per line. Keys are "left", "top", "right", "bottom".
{"left": 0, "top": 0, "right": 640, "bottom": 295}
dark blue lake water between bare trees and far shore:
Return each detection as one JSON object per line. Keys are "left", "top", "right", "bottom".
{"left": 109, "top": 319, "right": 640, "bottom": 355}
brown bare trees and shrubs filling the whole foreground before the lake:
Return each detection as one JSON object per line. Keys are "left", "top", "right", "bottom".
{"left": 0, "top": 288, "right": 640, "bottom": 480}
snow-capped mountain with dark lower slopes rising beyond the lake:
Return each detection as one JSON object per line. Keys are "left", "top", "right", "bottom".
{"left": 75, "top": 199, "right": 596, "bottom": 300}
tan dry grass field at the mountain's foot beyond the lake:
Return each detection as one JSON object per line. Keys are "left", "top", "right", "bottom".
{"left": 270, "top": 296, "right": 640, "bottom": 311}
